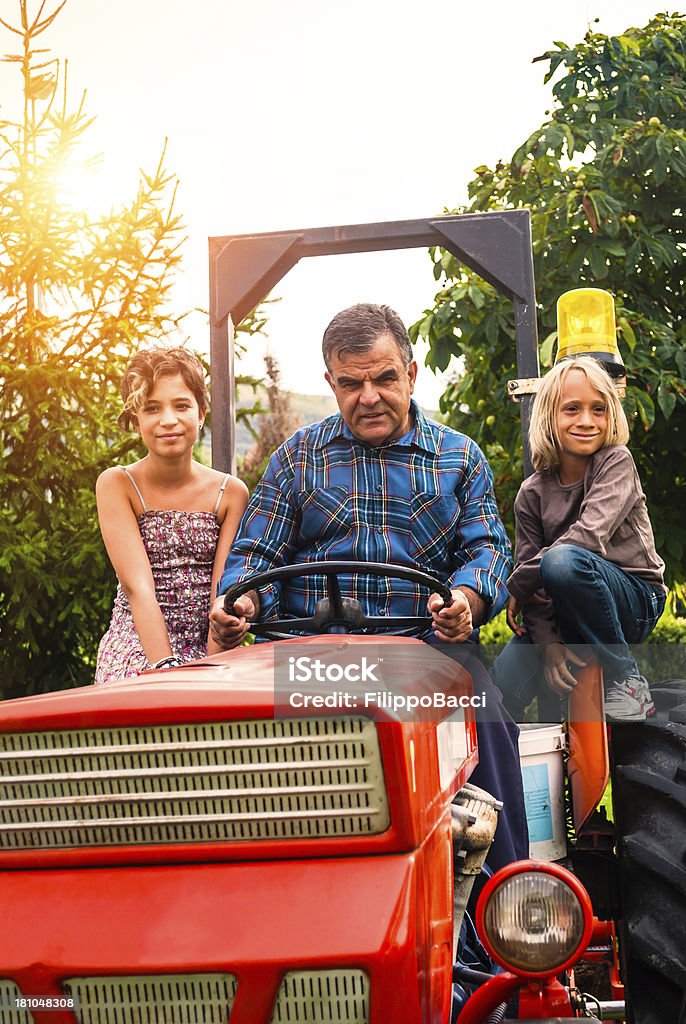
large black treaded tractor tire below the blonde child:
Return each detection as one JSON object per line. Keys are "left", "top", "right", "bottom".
{"left": 610, "top": 680, "right": 686, "bottom": 1024}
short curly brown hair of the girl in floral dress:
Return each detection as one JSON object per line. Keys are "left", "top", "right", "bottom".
{"left": 117, "top": 348, "right": 207, "bottom": 430}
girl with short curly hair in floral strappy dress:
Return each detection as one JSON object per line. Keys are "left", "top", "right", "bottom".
{"left": 95, "top": 348, "right": 248, "bottom": 683}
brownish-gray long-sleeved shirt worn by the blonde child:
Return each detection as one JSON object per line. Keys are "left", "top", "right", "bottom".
{"left": 508, "top": 444, "right": 664, "bottom": 644}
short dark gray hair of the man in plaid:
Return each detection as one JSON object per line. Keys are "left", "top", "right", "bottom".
{"left": 321, "top": 302, "right": 414, "bottom": 371}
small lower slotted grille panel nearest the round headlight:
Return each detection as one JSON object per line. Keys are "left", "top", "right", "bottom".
{"left": 271, "top": 971, "right": 370, "bottom": 1024}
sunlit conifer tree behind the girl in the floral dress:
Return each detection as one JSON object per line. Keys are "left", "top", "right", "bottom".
{"left": 0, "top": 0, "right": 188, "bottom": 696}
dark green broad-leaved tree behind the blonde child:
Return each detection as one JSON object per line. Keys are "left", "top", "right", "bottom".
{"left": 411, "top": 14, "right": 686, "bottom": 582}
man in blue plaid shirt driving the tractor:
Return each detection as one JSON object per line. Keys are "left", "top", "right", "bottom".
{"left": 211, "top": 303, "right": 528, "bottom": 868}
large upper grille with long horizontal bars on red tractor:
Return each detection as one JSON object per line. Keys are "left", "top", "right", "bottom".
{"left": 0, "top": 718, "right": 389, "bottom": 850}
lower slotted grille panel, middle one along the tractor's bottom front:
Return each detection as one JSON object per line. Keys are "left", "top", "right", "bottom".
{"left": 62, "top": 974, "right": 238, "bottom": 1024}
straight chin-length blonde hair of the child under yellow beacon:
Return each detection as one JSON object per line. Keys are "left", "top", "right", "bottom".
{"left": 528, "top": 355, "right": 629, "bottom": 473}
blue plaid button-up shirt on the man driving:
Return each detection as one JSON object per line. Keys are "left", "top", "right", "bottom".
{"left": 218, "top": 402, "right": 512, "bottom": 620}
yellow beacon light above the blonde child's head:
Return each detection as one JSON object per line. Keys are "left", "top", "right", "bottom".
{"left": 556, "top": 288, "right": 626, "bottom": 377}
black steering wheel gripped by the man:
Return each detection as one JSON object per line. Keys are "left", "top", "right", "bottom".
{"left": 224, "top": 561, "right": 453, "bottom": 640}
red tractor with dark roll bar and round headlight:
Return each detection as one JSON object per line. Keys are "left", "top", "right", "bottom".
{"left": 0, "top": 211, "right": 686, "bottom": 1024}
